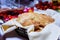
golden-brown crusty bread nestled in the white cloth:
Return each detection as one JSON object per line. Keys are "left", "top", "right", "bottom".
{"left": 17, "top": 13, "right": 54, "bottom": 31}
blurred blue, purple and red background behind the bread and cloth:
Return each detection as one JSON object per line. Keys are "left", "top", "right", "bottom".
{"left": 0, "top": 0, "right": 60, "bottom": 22}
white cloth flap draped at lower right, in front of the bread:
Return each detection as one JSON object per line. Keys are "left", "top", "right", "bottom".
{"left": 28, "top": 24, "right": 60, "bottom": 40}
